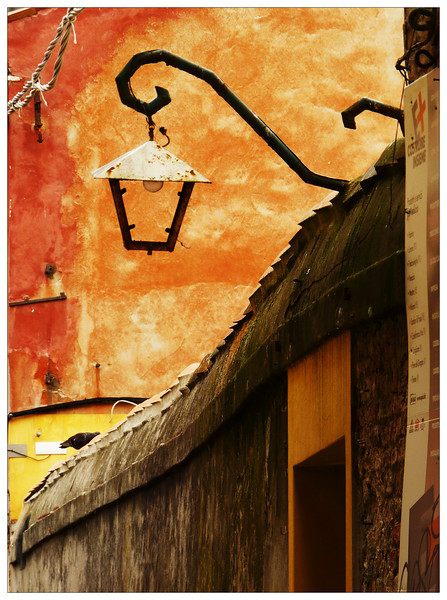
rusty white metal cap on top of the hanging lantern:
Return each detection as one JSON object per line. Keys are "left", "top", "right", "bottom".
{"left": 92, "top": 141, "right": 211, "bottom": 183}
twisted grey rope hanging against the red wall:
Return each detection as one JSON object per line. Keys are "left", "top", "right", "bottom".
{"left": 8, "top": 8, "right": 84, "bottom": 115}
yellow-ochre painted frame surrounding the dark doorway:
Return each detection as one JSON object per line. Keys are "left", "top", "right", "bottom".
{"left": 288, "top": 331, "right": 352, "bottom": 592}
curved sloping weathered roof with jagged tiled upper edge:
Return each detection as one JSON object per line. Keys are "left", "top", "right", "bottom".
{"left": 12, "top": 139, "right": 405, "bottom": 560}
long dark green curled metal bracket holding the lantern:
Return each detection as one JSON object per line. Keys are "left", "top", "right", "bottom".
{"left": 115, "top": 50, "right": 348, "bottom": 191}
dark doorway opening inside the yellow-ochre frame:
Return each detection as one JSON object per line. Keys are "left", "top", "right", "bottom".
{"left": 293, "top": 438, "right": 346, "bottom": 592}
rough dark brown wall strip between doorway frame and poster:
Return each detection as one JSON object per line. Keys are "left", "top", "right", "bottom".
{"left": 352, "top": 312, "right": 408, "bottom": 592}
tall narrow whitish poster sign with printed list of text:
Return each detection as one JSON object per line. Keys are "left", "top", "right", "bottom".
{"left": 399, "top": 69, "right": 440, "bottom": 592}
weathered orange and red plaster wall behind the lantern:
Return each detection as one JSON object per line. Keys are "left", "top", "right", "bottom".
{"left": 8, "top": 8, "right": 403, "bottom": 411}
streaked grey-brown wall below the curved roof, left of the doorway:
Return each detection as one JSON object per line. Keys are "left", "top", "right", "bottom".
{"left": 15, "top": 378, "right": 288, "bottom": 592}
